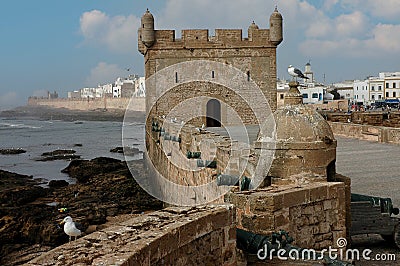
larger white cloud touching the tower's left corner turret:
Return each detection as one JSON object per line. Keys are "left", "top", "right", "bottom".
{"left": 80, "top": 10, "right": 140, "bottom": 54}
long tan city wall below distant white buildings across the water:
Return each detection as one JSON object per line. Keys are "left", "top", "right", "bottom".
{"left": 28, "top": 97, "right": 146, "bottom": 112}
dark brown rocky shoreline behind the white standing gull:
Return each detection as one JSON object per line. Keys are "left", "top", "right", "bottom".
{"left": 0, "top": 157, "right": 162, "bottom": 265}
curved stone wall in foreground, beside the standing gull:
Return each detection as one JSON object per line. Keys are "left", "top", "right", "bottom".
{"left": 27, "top": 205, "right": 236, "bottom": 266}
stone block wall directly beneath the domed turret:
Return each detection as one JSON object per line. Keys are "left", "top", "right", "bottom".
{"left": 226, "top": 182, "right": 346, "bottom": 250}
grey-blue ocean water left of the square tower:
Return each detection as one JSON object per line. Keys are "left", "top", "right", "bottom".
{"left": 0, "top": 118, "right": 144, "bottom": 183}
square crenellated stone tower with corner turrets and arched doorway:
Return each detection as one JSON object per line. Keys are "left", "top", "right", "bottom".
{"left": 138, "top": 9, "right": 283, "bottom": 126}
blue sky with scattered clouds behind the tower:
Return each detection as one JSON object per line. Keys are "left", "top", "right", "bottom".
{"left": 0, "top": 0, "right": 400, "bottom": 110}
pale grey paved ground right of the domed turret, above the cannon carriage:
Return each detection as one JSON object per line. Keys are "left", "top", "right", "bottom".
{"left": 336, "top": 137, "right": 400, "bottom": 207}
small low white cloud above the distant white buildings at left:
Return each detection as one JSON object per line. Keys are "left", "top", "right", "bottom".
{"left": 85, "top": 62, "right": 126, "bottom": 87}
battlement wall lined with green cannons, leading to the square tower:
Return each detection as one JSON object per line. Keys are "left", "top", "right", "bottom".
{"left": 146, "top": 118, "right": 246, "bottom": 204}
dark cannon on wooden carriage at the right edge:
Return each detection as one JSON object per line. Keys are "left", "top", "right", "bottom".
{"left": 350, "top": 193, "right": 400, "bottom": 248}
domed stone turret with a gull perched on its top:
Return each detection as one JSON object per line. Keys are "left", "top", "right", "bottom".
{"left": 258, "top": 82, "right": 337, "bottom": 183}
